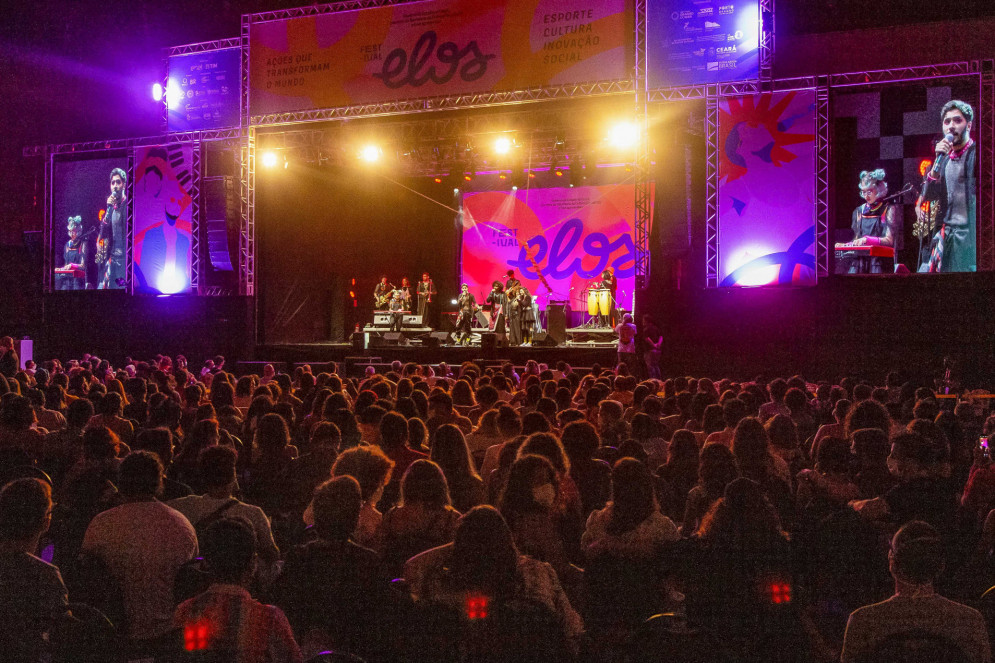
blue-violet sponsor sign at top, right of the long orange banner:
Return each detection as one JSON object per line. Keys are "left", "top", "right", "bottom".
{"left": 646, "top": 0, "right": 760, "bottom": 88}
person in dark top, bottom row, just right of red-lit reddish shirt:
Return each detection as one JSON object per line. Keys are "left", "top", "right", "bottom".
{"left": 273, "top": 475, "right": 393, "bottom": 655}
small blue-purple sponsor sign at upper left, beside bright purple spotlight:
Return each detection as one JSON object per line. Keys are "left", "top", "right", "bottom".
{"left": 166, "top": 48, "right": 242, "bottom": 131}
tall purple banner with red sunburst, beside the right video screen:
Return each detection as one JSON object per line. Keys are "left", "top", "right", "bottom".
{"left": 718, "top": 90, "right": 816, "bottom": 287}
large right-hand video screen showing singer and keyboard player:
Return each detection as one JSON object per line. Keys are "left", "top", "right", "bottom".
{"left": 833, "top": 79, "right": 979, "bottom": 274}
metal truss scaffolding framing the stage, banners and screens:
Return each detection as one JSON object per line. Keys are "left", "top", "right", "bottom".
{"left": 23, "top": 0, "right": 995, "bottom": 296}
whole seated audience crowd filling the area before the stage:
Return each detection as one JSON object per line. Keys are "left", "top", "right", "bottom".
{"left": 0, "top": 344, "right": 995, "bottom": 663}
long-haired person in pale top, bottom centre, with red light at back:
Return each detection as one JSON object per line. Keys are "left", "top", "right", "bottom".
{"left": 404, "top": 506, "right": 584, "bottom": 640}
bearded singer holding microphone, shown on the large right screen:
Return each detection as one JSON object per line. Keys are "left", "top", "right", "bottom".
{"left": 916, "top": 99, "right": 978, "bottom": 272}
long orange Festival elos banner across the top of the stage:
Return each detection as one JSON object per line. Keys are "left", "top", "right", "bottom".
{"left": 249, "top": 0, "right": 634, "bottom": 115}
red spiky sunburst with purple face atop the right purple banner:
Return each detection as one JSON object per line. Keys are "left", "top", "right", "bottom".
{"left": 719, "top": 92, "right": 815, "bottom": 183}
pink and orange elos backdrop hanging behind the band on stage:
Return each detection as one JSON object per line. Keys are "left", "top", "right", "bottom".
{"left": 462, "top": 184, "right": 636, "bottom": 310}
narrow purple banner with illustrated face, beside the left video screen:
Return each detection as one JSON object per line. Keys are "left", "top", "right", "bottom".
{"left": 133, "top": 145, "right": 194, "bottom": 295}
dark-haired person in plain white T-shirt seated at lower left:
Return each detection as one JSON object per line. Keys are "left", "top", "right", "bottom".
{"left": 81, "top": 451, "right": 197, "bottom": 641}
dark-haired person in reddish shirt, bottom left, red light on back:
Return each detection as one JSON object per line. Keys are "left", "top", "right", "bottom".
{"left": 173, "top": 518, "right": 304, "bottom": 663}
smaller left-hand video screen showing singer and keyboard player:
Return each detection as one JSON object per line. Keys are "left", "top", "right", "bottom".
{"left": 50, "top": 152, "right": 130, "bottom": 290}
